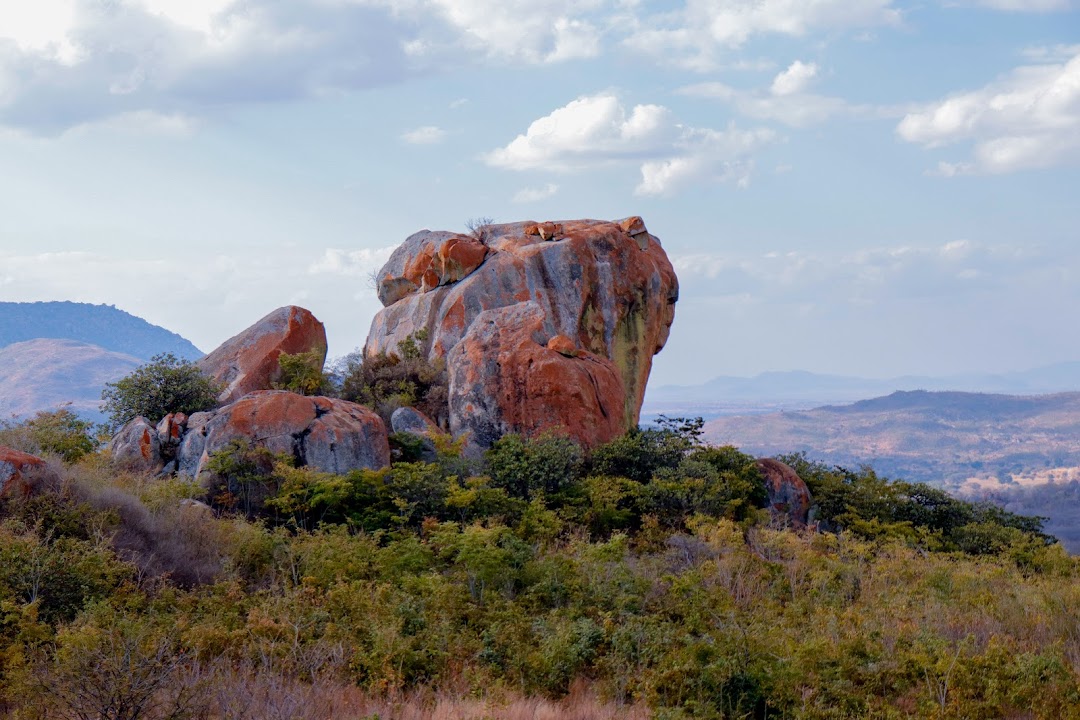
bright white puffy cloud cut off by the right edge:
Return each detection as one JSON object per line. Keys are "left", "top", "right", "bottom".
{"left": 896, "top": 52, "right": 1080, "bottom": 175}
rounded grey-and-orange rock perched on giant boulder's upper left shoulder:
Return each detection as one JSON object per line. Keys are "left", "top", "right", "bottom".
{"left": 378, "top": 230, "right": 487, "bottom": 305}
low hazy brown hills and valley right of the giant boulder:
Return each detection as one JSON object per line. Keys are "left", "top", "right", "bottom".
{"left": 705, "top": 391, "right": 1080, "bottom": 489}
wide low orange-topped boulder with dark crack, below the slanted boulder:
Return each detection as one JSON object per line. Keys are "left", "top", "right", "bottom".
{"left": 176, "top": 390, "right": 390, "bottom": 477}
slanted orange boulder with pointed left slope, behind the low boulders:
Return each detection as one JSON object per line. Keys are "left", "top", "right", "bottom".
{"left": 198, "top": 305, "right": 326, "bottom": 403}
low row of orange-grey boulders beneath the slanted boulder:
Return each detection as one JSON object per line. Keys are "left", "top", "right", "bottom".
{"left": 109, "top": 390, "right": 390, "bottom": 477}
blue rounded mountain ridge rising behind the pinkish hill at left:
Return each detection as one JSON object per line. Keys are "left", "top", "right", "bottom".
{"left": 0, "top": 302, "right": 203, "bottom": 361}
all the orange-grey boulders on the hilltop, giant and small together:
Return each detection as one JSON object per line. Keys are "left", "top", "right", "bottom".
{"left": 103, "top": 217, "right": 810, "bottom": 524}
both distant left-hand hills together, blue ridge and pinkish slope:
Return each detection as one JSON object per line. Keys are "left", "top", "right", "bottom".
{"left": 0, "top": 302, "right": 203, "bottom": 420}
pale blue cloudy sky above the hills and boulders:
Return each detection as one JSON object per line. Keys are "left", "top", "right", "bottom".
{"left": 0, "top": 0, "right": 1080, "bottom": 384}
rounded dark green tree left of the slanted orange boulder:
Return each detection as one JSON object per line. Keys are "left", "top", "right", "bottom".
{"left": 102, "top": 353, "right": 221, "bottom": 430}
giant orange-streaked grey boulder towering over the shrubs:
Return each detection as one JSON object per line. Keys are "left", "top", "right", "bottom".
{"left": 365, "top": 217, "right": 678, "bottom": 447}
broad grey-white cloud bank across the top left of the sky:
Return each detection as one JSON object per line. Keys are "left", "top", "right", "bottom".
{"left": 0, "top": 0, "right": 615, "bottom": 135}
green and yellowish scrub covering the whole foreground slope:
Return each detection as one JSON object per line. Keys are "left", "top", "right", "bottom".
{"left": 0, "top": 408, "right": 1080, "bottom": 720}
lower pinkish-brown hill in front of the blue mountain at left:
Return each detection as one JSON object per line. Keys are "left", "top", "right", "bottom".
{"left": 0, "top": 339, "right": 143, "bottom": 420}
